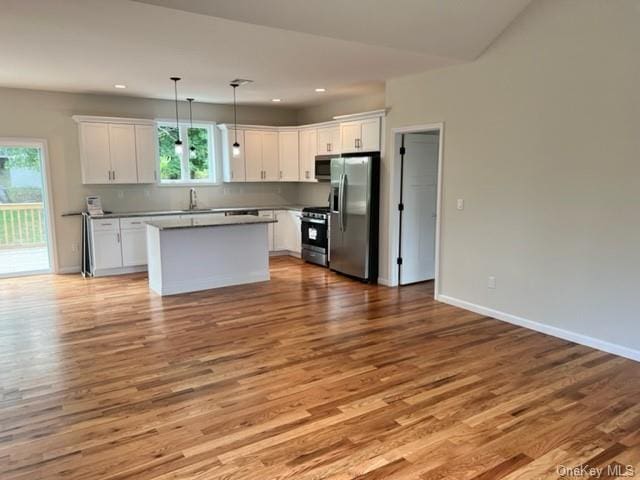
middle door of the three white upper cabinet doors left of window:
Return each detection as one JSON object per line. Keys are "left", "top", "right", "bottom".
{"left": 109, "top": 123, "right": 138, "bottom": 183}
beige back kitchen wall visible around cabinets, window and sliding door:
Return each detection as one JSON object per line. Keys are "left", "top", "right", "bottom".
{"left": 0, "top": 89, "right": 298, "bottom": 269}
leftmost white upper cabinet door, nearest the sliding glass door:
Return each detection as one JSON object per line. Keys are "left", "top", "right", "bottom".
{"left": 78, "top": 122, "right": 111, "bottom": 184}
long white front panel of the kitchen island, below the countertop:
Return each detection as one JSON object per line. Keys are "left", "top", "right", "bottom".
{"left": 159, "top": 223, "right": 270, "bottom": 295}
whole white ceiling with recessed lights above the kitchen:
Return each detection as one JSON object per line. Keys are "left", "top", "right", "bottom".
{"left": 0, "top": 0, "right": 530, "bottom": 106}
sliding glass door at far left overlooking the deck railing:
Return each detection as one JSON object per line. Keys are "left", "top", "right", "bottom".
{"left": 0, "top": 139, "right": 51, "bottom": 277}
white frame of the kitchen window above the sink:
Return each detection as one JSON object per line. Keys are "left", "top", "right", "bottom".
{"left": 156, "top": 119, "right": 221, "bottom": 187}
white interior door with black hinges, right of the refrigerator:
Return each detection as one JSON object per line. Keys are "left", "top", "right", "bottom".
{"left": 400, "top": 132, "right": 439, "bottom": 285}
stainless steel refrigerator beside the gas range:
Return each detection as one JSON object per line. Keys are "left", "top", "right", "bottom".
{"left": 329, "top": 153, "right": 380, "bottom": 283}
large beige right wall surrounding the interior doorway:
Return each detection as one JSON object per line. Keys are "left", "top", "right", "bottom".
{"left": 381, "top": 0, "right": 640, "bottom": 351}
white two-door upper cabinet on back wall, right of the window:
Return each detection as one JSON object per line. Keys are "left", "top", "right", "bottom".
{"left": 244, "top": 130, "right": 280, "bottom": 182}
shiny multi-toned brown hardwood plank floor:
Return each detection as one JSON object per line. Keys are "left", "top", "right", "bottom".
{"left": 0, "top": 258, "right": 640, "bottom": 480}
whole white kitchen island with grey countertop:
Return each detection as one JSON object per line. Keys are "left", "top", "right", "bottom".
{"left": 146, "top": 215, "right": 276, "bottom": 295}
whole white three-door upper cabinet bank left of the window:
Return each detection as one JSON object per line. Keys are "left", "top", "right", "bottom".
{"left": 73, "top": 116, "right": 157, "bottom": 184}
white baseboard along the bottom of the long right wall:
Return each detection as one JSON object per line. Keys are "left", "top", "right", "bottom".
{"left": 436, "top": 295, "right": 640, "bottom": 362}
